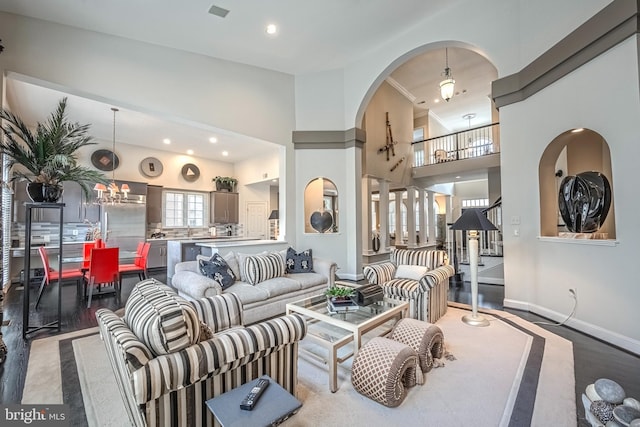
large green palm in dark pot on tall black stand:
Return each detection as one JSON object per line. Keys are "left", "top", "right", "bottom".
{"left": 0, "top": 98, "right": 108, "bottom": 202}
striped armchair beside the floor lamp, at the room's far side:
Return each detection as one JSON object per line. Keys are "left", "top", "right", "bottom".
{"left": 363, "top": 249, "right": 455, "bottom": 323}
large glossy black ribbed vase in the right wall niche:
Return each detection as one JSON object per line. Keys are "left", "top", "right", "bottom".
{"left": 558, "top": 172, "right": 611, "bottom": 233}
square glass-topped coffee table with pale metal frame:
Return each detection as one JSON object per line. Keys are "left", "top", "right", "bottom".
{"left": 287, "top": 295, "right": 409, "bottom": 393}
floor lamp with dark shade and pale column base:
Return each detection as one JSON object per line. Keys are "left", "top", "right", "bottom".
{"left": 451, "top": 208, "right": 497, "bottom": 326}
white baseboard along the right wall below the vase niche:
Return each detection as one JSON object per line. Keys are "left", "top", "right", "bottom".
{"left": 503, "top": 298, "right": 640, "bottom": 355}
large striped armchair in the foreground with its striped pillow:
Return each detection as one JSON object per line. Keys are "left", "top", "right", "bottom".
{"left": 96, "top": 279, "right": 307, "bottom": 427}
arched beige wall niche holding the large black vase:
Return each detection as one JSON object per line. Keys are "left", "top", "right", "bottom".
{"left": 538, "top": 129, "right": 616, "bottom": 239}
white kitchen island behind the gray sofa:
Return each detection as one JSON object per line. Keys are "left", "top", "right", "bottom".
{"left": 167, "top": 237, "right": 289, "bottom": 283}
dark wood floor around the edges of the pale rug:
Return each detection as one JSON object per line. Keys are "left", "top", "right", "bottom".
{"left": 0, "top": 273, "right": 640, "bottom": 426}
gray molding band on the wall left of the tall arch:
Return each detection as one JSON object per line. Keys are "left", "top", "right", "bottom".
{"left": 292, "top": 128, "right": 367, "bottom": 150}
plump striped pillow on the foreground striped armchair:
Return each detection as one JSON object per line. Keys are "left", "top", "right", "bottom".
{"left": 124, "top": 279, "right": 200, "bottom": 356}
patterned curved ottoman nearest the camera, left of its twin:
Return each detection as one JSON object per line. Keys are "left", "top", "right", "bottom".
{"left": 351, "top": 337, "right": 422, "bottom": 408}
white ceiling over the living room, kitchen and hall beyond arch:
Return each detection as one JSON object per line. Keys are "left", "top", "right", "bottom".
{"left": 0, "top": 0, "right": 497, "bottom": 163}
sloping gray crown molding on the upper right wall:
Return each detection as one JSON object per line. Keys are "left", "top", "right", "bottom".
{"left": 491, "top": 0, "right": 640, "bottom": 108}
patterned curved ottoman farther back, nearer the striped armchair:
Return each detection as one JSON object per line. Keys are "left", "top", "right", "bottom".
{"left": 389, "top": 318, "right": 444, "bottom": 373}
